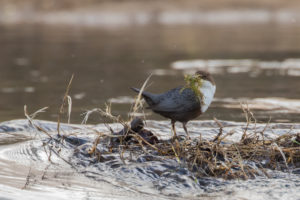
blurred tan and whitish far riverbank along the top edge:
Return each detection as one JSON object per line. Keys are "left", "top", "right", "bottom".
{"left": 0, "top": 0, "right": 300, "bottom": 27}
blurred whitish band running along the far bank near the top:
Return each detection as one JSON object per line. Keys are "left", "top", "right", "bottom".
{"left": 0, "top": 8, "right": 300, "bottom": 27}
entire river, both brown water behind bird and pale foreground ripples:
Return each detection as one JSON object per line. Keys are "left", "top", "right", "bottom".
{"left": 0, "top": 16, "right": 300, "bottom": 199}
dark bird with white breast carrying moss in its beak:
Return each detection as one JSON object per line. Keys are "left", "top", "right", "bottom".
{"left": 131, "top": 71, "right": 216, "bottom": 139}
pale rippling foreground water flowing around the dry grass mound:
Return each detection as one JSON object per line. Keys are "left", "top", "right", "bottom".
{"left": 0, "top": 120, "right": 300, "bottom": 199}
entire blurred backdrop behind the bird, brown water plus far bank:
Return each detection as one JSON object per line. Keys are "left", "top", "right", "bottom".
{"left": 0, "top": 0, "right": 300, "bottom": 123}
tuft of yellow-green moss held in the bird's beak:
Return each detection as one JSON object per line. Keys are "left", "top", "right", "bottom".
{"left": 180, "top": 74, "right": 203, "bottom": 101}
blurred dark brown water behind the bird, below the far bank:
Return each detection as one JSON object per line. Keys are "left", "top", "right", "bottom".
{"left": 0, "top": 24, "right": 300, "bottom": 123}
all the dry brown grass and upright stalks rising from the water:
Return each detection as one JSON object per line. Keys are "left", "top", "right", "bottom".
{"left": 24, "top": 75, "right": 300, "bottom": 179}
